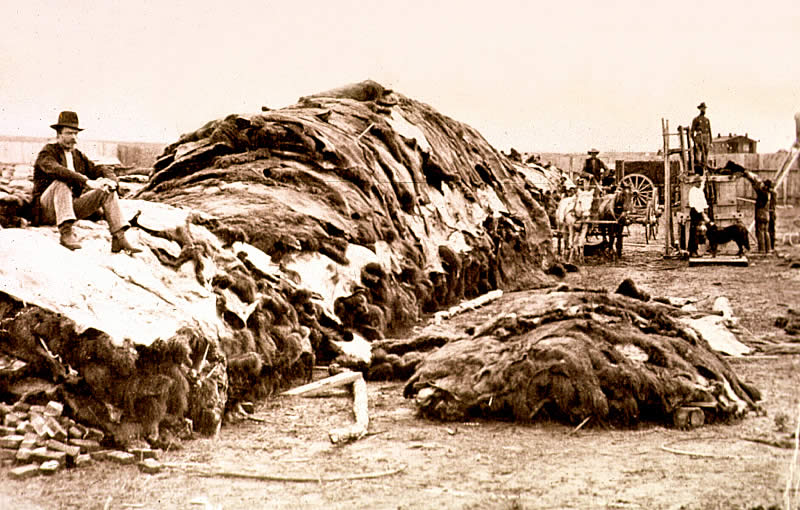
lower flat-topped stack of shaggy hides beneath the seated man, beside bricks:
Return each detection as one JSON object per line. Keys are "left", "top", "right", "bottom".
{"left": 0, "top": 200, "right": 318, "bottom": 444}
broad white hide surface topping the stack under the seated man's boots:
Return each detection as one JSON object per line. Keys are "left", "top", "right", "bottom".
{"left": 0, "top": 201, "right": 228, "bottom": 345}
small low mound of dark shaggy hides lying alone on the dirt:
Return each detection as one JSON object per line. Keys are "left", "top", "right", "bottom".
{"left": 405, "top": 289, "right": 760, "bottom": 426}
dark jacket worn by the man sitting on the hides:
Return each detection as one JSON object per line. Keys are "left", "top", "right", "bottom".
{"left": 33, "top": 143, "right": 117, "bottom": 214}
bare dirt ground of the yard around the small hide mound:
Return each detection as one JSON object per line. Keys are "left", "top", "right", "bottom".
{"left": 0, "top": 205, "right": 800, "bottom": 510}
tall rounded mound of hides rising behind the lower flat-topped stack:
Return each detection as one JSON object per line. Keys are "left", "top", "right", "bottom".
{"left": 138, "top": 81, "right": 551, "bottom": 340}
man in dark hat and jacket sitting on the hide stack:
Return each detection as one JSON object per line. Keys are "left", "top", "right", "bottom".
{"left": 33, "top": 111, "right": 141, "bottom": 254}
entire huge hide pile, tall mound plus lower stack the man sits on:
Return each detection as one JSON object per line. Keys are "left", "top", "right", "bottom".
{"left": 0, "top": 81, "right": 552, "bottom": 442}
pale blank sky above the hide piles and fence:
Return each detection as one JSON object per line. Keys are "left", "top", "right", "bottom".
{"left": 0, "top": 0, "right": 800, "bottom": 152}
